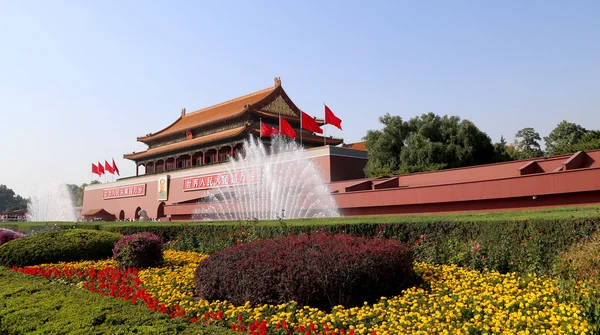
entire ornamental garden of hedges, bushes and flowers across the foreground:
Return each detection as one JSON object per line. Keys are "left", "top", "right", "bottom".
{"left": 0, "top": 206, "right": 600, "bottom": 335}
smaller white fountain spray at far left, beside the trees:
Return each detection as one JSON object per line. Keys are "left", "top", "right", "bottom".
{"left": 27, "top": 180, "right": 77, "bottom": 222}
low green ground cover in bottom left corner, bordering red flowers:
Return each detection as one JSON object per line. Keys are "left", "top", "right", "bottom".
{"left": 0, "top": 267, "right": 235, "bottom": 335}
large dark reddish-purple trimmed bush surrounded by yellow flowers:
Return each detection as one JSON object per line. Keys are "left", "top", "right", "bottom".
{"left": 194, "top": 233, "right": 416, "bottom": 309}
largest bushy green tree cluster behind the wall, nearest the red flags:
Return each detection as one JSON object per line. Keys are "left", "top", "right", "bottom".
{"left": 364, "top": 113, "right": 495, "bottom": 177}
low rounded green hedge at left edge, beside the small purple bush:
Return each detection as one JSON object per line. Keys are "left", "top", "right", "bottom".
{"left": 0, "top": 229, "right": 122, "bottom": 267}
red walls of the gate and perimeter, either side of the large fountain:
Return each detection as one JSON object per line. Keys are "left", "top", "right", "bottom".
{"left": 83, "top": 147, "right": 600, "bottom": 220}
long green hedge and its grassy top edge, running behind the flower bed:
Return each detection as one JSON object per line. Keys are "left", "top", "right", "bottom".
{"left": 5, "top": 205, "right": 600, "bottom": 273}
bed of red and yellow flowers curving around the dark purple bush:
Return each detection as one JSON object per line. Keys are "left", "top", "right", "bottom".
{"left": 13, "top": 251, "right": 589, "bottom": 335}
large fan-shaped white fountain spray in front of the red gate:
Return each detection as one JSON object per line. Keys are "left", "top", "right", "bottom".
{"left": 192, "top": 135, "right": 340, "bottom": 220}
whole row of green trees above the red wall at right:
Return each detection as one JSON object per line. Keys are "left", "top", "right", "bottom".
{"left": 363, "top": 113, "right": 600, "bottom": 177}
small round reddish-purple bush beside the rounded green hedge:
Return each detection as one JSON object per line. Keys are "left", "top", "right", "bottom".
{"left": 113, "top": 233, "right": 163, "bottom": 269}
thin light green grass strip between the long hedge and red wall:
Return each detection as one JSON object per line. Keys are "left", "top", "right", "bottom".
{"left": 0, "top": 205, "right": 600, "bottom": 231}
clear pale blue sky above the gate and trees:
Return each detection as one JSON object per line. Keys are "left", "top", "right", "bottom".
{"left": 0, "top": 0, "right": 600, "bottom": 197}
